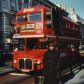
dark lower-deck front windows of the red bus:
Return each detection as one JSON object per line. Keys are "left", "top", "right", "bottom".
{"left": 14, "top": 38, "right": 49, "bottom": 51}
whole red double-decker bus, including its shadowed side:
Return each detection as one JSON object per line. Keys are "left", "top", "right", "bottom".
{"left": 13, "top": 6, "right": 80, "bottom": 72}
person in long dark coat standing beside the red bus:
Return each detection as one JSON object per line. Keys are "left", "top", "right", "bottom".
{"left": 43, "top": 43, "right": 59, "bottom": 84}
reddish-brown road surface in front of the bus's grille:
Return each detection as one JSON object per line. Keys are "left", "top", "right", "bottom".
{"left": 0, "top": 73, "right": 34, "bottom": 84}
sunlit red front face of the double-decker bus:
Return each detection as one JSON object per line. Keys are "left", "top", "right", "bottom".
{"left": 13, "top": 7, "right": 50, "bottom": 72}
